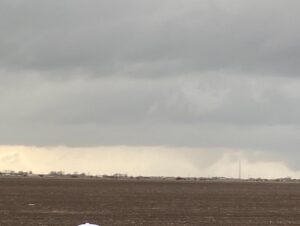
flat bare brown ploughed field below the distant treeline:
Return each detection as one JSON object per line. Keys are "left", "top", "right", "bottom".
{"left": 0, "top": 178, "right": 300, "bottom": 226}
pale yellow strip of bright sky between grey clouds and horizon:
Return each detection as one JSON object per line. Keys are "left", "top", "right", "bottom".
{"left": 0, "top": 146, "right": 300, "bottom": 179}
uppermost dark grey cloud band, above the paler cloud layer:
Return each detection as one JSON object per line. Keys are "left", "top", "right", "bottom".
{"left": 0, "top": 0, "right": 300, "bottom": 77}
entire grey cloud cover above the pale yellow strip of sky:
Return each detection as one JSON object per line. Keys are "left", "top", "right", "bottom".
{"left": 0, "top": 0, "right": 300, "bottom": 177}
